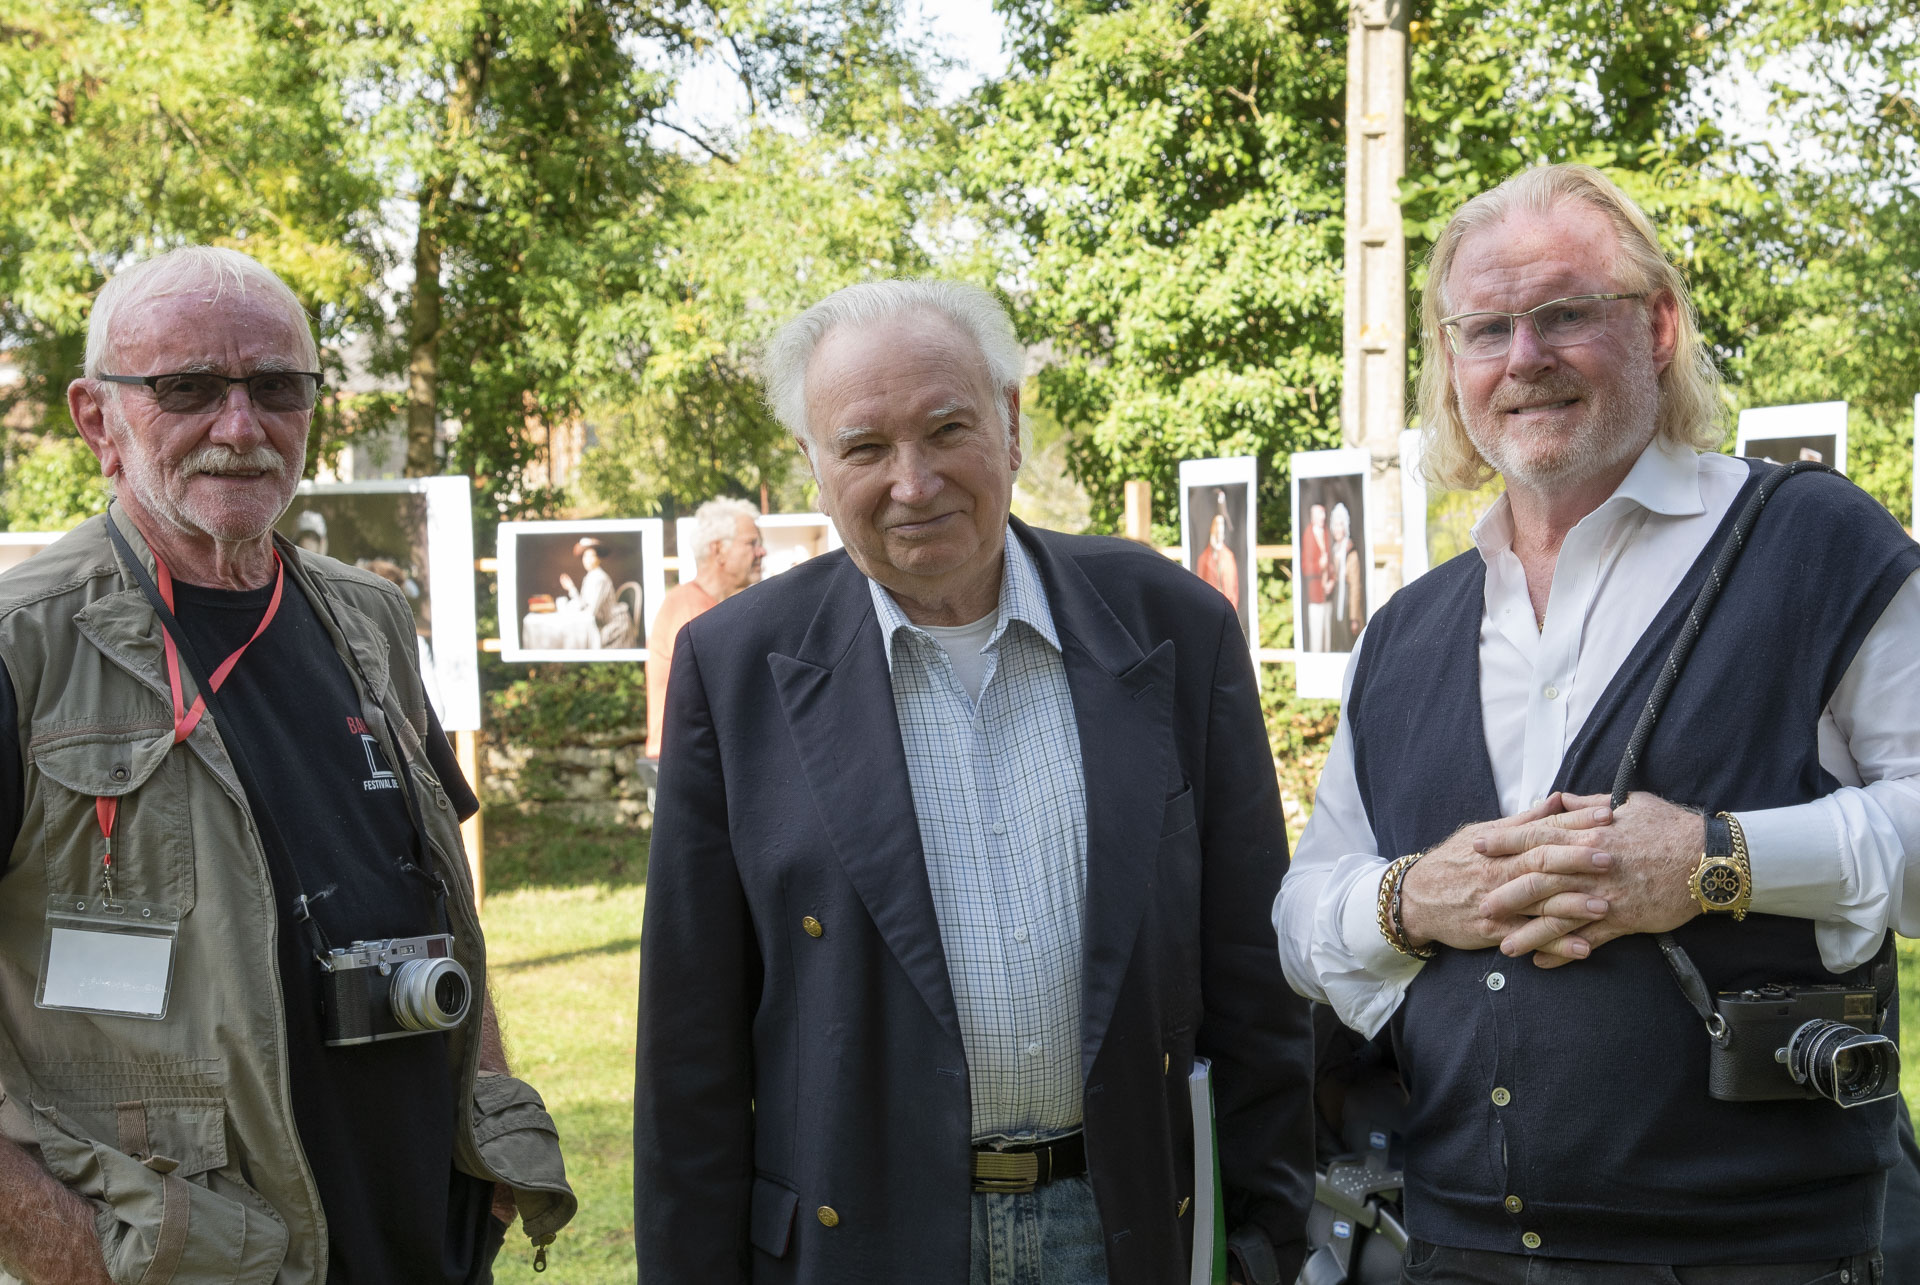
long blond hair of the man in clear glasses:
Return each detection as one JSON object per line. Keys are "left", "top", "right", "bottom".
{"left": 1419, "top": 165, "right": 1726, "bottom": 490}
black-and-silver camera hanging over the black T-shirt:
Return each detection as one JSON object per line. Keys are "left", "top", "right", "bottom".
{"left": 321, "top": 933, "right": 472, "bottom": 1045}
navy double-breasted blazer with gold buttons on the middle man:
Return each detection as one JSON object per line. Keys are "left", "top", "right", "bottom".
{"left": 634, "top": 521, "right": 1313, "bottom": 1285}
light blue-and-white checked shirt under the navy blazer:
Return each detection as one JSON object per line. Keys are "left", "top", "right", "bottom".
{"left": 868, "top": 532, "right": 1087, "bottom": 1143}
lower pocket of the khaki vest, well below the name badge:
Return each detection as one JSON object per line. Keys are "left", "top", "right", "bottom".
{"left": 33, "top": 1099, "right": 288, "bottom": 1285}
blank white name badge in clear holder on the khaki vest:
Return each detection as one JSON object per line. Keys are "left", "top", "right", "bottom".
{"left": 33, "top": 895, "right": 180, "bottom": 1022}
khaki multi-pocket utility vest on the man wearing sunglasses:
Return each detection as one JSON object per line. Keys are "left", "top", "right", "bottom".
{"left": 0, "top": 507, "right": 576, "bottom": 1285}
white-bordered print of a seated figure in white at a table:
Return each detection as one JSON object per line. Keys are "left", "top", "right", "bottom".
{"left": 499, "top": 517, "right": 666, "bottom": 661}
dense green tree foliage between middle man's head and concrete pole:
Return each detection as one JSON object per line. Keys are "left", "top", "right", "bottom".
{"left": 960, "top": 0, "right": 1346, "bottom": 534}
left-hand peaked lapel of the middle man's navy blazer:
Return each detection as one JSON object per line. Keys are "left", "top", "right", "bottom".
{"left": 766, "top": 561, "right": 960, "bottom": 1041}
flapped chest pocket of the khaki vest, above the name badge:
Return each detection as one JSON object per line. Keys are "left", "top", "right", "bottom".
{"left": 27, "top": 724, "right": 194, "bottom": 916}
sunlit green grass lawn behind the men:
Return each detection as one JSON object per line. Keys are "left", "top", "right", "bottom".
{"left": 484, "top": 811, "right": 1920, "bottom": 1285}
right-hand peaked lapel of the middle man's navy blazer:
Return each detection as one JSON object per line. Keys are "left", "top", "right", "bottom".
{"left": 1014, "top": 522, "right": 1179, "bottom": 1072}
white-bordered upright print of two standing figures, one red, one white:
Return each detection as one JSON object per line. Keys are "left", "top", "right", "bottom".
{"left": 1290, "top": 449, "right": 1373, "bottom": 699}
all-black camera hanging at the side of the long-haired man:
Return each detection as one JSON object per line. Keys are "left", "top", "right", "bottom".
{"left": 1707, "top": 983, "right": 1901, "bottom": 1106}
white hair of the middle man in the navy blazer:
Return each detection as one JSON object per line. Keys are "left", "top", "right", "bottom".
{"left": 760, "top": 277, "right": 1027, "bottom": 446}
